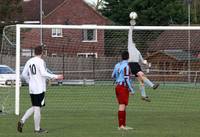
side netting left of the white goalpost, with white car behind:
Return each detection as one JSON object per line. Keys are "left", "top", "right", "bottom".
{"left": 0, "top": 25, "right": 16, "bottom": 115}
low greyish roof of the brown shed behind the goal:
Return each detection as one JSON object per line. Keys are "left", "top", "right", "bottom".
{"left": 148, "top": 50, "right": 200, "bottom": 61}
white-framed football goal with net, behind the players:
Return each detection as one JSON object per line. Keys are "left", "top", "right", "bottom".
{"left": 2, "top": 25, "right": 200, "bottom": 120}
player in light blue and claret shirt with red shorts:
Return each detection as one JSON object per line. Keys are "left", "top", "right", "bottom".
{"left": 112, "top": 51, "right": 135, "bottom": 130}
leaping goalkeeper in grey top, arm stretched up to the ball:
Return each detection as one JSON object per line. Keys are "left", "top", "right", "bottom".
{"left": 128, "top": 26, "right": 159, "bottom": 102}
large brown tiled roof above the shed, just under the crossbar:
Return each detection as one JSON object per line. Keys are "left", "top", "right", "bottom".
{"left": 148, "top": 30, "right": 200, "bottom": 52}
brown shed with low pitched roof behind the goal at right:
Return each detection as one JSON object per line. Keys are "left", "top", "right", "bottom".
{"left": 146, "top": 50, "right": 200, "bottom": 82}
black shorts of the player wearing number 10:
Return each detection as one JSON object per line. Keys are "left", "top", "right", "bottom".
{"left": 30, "top": 92, "right": 45, "bottom": 107}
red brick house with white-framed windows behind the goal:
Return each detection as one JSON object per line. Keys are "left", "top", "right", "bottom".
{"left": 22, "top": 0, "right": 110, "bottom": 57}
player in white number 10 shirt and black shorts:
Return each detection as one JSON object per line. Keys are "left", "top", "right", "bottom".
{"left": 17, "top": 46, "right": 63, "bottom": 133}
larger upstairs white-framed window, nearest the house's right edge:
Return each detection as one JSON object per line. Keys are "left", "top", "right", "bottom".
{"left": 83, "top": 29, "right": 97, "bottom": 42}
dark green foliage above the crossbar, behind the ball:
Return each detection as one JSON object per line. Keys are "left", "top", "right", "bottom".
{"left": 99, "top": 0, "right": 187, "bottom": 26}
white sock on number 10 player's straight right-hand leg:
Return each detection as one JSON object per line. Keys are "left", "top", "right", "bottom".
{"left": 34, "top": 107, "right": 41, "bottom": 131}
